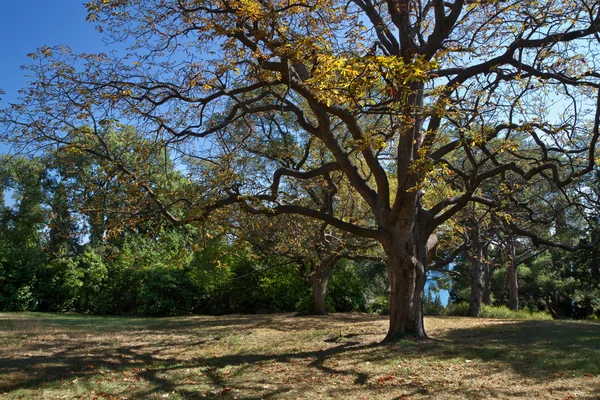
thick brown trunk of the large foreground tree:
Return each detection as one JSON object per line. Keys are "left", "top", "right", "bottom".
{"left": 376, "top": 82, "right": 428, "bottom": 341}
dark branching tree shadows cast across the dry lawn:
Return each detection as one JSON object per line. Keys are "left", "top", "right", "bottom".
{"left": 0, "top": 314, "right": 600, "bottom": 399}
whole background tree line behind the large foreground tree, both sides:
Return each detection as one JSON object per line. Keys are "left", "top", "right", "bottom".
{"left": 0, "top": 153, "right": 600, "bottom": 318}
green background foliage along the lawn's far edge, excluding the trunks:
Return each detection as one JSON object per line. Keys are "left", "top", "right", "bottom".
{"left": 0, "top": 150, "right": 600, "bottom": 319}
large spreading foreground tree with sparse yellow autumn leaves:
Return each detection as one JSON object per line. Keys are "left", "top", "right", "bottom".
{"left": 1, "top": 0, "right": 600, "bottom": 339}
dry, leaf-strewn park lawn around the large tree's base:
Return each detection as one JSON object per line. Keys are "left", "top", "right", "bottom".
{"left": 0, "top": 313, "right": 600, "bottom": 399}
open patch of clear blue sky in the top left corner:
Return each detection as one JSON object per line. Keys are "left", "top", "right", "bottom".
{"left": 0, "top": 0, "right": 108, "bottom": 108}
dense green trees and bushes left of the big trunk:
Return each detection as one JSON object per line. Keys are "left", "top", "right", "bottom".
{"left": 0, "top": 156, "right": 376, "bottom": 316}
